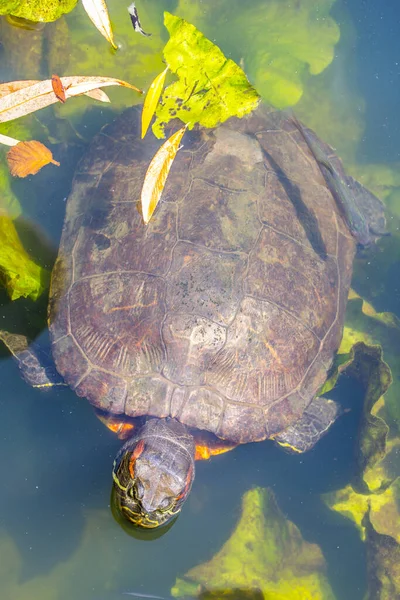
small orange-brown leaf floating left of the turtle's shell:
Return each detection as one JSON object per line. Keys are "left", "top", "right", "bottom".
{"left": 7, "top": 140, "right": 60, "bottom": 177}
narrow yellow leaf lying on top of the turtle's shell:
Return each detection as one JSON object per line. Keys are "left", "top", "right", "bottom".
{"left": 141, "top": 126, "right": 186, "bottom": 224}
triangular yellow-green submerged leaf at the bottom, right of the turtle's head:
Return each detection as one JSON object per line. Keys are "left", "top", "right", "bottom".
{"left": 171, "top": 488, "right": 334, "bottom": 600}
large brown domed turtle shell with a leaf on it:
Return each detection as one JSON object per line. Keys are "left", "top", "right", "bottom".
{"left": 50, "top": 107, "right": 355, "bottom": 443}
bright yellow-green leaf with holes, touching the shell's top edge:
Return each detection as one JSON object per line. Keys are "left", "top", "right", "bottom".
{"left": 153, "top": 12, "right": 260, "bottom": 137}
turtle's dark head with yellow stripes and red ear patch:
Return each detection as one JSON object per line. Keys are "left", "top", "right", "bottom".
{"left": 113, "top": 419, "right": 195, "bottom": 528}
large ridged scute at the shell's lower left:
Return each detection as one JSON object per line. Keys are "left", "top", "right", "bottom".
{"left": 70, "top": 273, "right": 165, "bottom": 376}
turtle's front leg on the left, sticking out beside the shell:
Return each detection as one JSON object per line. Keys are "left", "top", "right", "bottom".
{"left": 0, "top": 330, "right": 66, "bottom": 389}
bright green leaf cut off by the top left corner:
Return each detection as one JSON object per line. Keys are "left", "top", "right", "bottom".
{"left": 0, "top": 0, "right": 78, "bottom": 22}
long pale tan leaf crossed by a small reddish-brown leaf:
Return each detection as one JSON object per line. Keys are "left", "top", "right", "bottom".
{"left": 0, "top": 76, "right": 143, "bottom": 123}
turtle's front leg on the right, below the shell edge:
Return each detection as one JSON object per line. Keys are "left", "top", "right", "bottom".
{"left": 273, "top": 396, "right": 341, "bottom": 452}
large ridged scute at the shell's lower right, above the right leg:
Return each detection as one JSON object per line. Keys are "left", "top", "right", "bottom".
{"left": 206, "top": 298, "right": 319, "bottom": 406}
